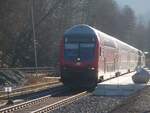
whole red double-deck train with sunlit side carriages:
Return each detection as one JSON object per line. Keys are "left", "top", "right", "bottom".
{"left": 60, "top": 24, "right": 145, "bottom": 88}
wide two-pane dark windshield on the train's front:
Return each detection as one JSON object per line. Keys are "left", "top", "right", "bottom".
{"left": 64, "top": 36, "right": 95, "bottom": 61}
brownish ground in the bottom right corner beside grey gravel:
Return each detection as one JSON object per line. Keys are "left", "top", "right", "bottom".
{"left": 111, "top": 86, "right": 150, "bottom": 113}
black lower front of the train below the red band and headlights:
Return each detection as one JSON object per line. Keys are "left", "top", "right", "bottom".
{"left": 61, "top": 69, "right": 98, "bottom": 89}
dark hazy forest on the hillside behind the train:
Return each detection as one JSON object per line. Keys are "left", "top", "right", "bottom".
{"left": 0, "top": 0, "right": 150, "bottom": 67}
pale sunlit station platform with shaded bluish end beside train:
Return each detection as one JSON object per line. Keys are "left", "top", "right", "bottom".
{"left": 93, "top": 72, "right": 150, "bottom": 96}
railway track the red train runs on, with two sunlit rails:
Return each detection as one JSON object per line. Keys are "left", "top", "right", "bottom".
{"left": 0, "top": 71, "right": 134, "bottom": 113}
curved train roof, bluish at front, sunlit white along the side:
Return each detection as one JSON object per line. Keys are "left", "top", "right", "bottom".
{"left": 64, "top": 24, "right": 140, "bottom": 51}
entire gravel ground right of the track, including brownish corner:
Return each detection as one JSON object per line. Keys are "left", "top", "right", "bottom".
{"left": 50, "top": 86, "right": 150, "bottom": 113}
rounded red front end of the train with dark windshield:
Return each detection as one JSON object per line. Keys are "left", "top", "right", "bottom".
{"left": 60, "top": 25, "right": 98, "bottom": 88}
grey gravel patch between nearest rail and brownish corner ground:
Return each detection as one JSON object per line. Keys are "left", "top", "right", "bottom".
{"left": 50, "top": 95, "right": 126, "bottom": 113}
